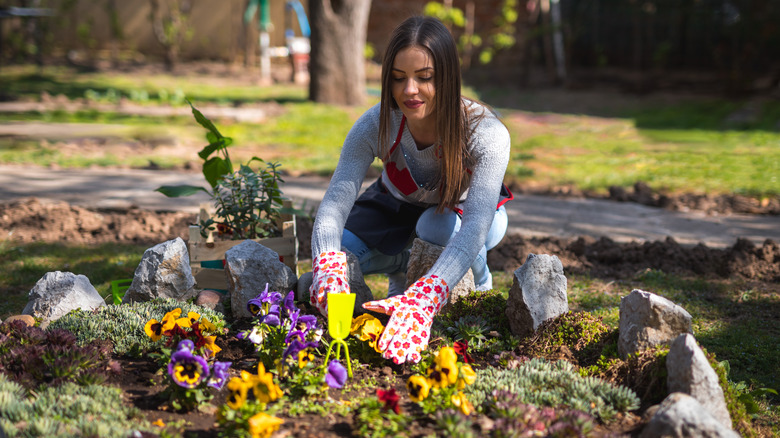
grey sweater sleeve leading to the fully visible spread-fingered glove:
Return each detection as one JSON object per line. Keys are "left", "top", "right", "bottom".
{"left": 427, "top": 108, "right": 510, "bottom": 288}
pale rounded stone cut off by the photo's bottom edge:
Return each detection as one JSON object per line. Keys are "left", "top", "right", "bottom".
{"left": 639, "top": 392, "right": 739, "bottom": 438}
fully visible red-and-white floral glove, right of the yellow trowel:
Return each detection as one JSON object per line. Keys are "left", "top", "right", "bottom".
{"left": 363, "top": 275, "right": 450, "bottom": 364}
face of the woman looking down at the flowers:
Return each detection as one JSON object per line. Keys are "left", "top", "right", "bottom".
{"left": 390, "top": 46, "right": 436, "bottom": 127}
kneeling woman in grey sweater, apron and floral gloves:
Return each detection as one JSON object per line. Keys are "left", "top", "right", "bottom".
{"left": 310, "top": 17, "right": 512, "bottom": 363}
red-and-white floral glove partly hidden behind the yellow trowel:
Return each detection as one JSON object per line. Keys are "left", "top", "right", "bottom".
{"left": 309, "top": 251, "right": 349, "bottom": 317}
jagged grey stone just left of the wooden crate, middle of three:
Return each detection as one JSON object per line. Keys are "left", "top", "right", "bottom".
{"left": 122, "top": 237, "right": 197, "bottom": 304}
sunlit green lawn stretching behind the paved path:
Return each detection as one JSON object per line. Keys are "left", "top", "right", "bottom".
{"left": 0, "top": 67, "right": 780, "bottom": 198}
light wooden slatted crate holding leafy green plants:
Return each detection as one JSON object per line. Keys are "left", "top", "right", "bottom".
{"left": 188, "top": 201, "right": 298, "bottom": 290}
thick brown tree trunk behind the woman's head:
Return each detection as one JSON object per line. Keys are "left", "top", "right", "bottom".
{"left": 309, "top": 0, "right": 371, "bottom": 105}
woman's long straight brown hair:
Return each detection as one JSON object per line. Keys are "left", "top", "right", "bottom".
{"left": 379, "top": 17, "right": 474, "bottom": 211}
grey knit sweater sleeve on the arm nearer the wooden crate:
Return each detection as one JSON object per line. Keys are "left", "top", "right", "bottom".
{"left": 311, "top": 104, "right": 379, "bottom": 258}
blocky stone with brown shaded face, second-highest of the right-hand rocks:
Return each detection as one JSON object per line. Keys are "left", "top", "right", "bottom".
{"left": 618, "top": 289, "right": 693, "bottom": 359}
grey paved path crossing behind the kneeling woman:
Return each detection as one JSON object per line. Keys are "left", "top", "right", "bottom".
{"left": 0, "top": 165, "right": 780, "bottom": 248}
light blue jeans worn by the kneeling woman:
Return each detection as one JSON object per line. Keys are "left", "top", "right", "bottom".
{"left": 341, "top": 206, "right": 508, "bottom": 287}
